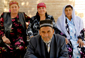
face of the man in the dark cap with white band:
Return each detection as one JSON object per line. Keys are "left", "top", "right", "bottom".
{"left": 39, "top": 26, "right": 54, "bottom": 43}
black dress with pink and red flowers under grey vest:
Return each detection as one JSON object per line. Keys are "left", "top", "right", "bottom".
{"left": 0, "top": 14, "right": 29, "bottom": 58}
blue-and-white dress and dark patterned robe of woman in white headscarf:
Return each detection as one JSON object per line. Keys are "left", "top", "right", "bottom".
{"left": 57, "top": 18, "right": 84, "bottom": 58}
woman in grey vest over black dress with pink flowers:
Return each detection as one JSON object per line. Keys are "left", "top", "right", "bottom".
{"left": 0, "top": 1, "right": 30, "bottom": 58}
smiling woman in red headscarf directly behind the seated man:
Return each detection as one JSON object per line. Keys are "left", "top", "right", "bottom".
{"left": 28, "top": 3, "right": 55, "bottom": 37}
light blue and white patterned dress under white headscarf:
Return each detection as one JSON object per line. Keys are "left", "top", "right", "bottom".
{"left": 67, "top": 18, "right": 80, "bottom": 58}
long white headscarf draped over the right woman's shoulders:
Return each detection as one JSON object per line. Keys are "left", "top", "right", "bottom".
{"left": 56, "top": 5, "right": 83, "bottom": 39}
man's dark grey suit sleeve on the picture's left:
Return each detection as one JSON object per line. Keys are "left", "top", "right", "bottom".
{"left": 24, "top": 38, "right": 37, "bottom": 58}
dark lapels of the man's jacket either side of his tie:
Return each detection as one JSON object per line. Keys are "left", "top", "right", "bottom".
{"left": 39, "top": 35, "right": 56, "bottom": 58}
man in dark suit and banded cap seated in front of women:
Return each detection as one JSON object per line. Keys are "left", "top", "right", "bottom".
{"left": 24, "top": 20, "right": 68, "bottom": 58}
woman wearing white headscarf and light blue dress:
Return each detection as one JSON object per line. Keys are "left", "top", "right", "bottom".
{"left": 56, "top": 5, "right": 84, "bottom": 58}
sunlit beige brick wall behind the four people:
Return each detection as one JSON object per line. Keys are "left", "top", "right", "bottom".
{"left": 0, "top": 0, "right": 85, "bottom": 27}
